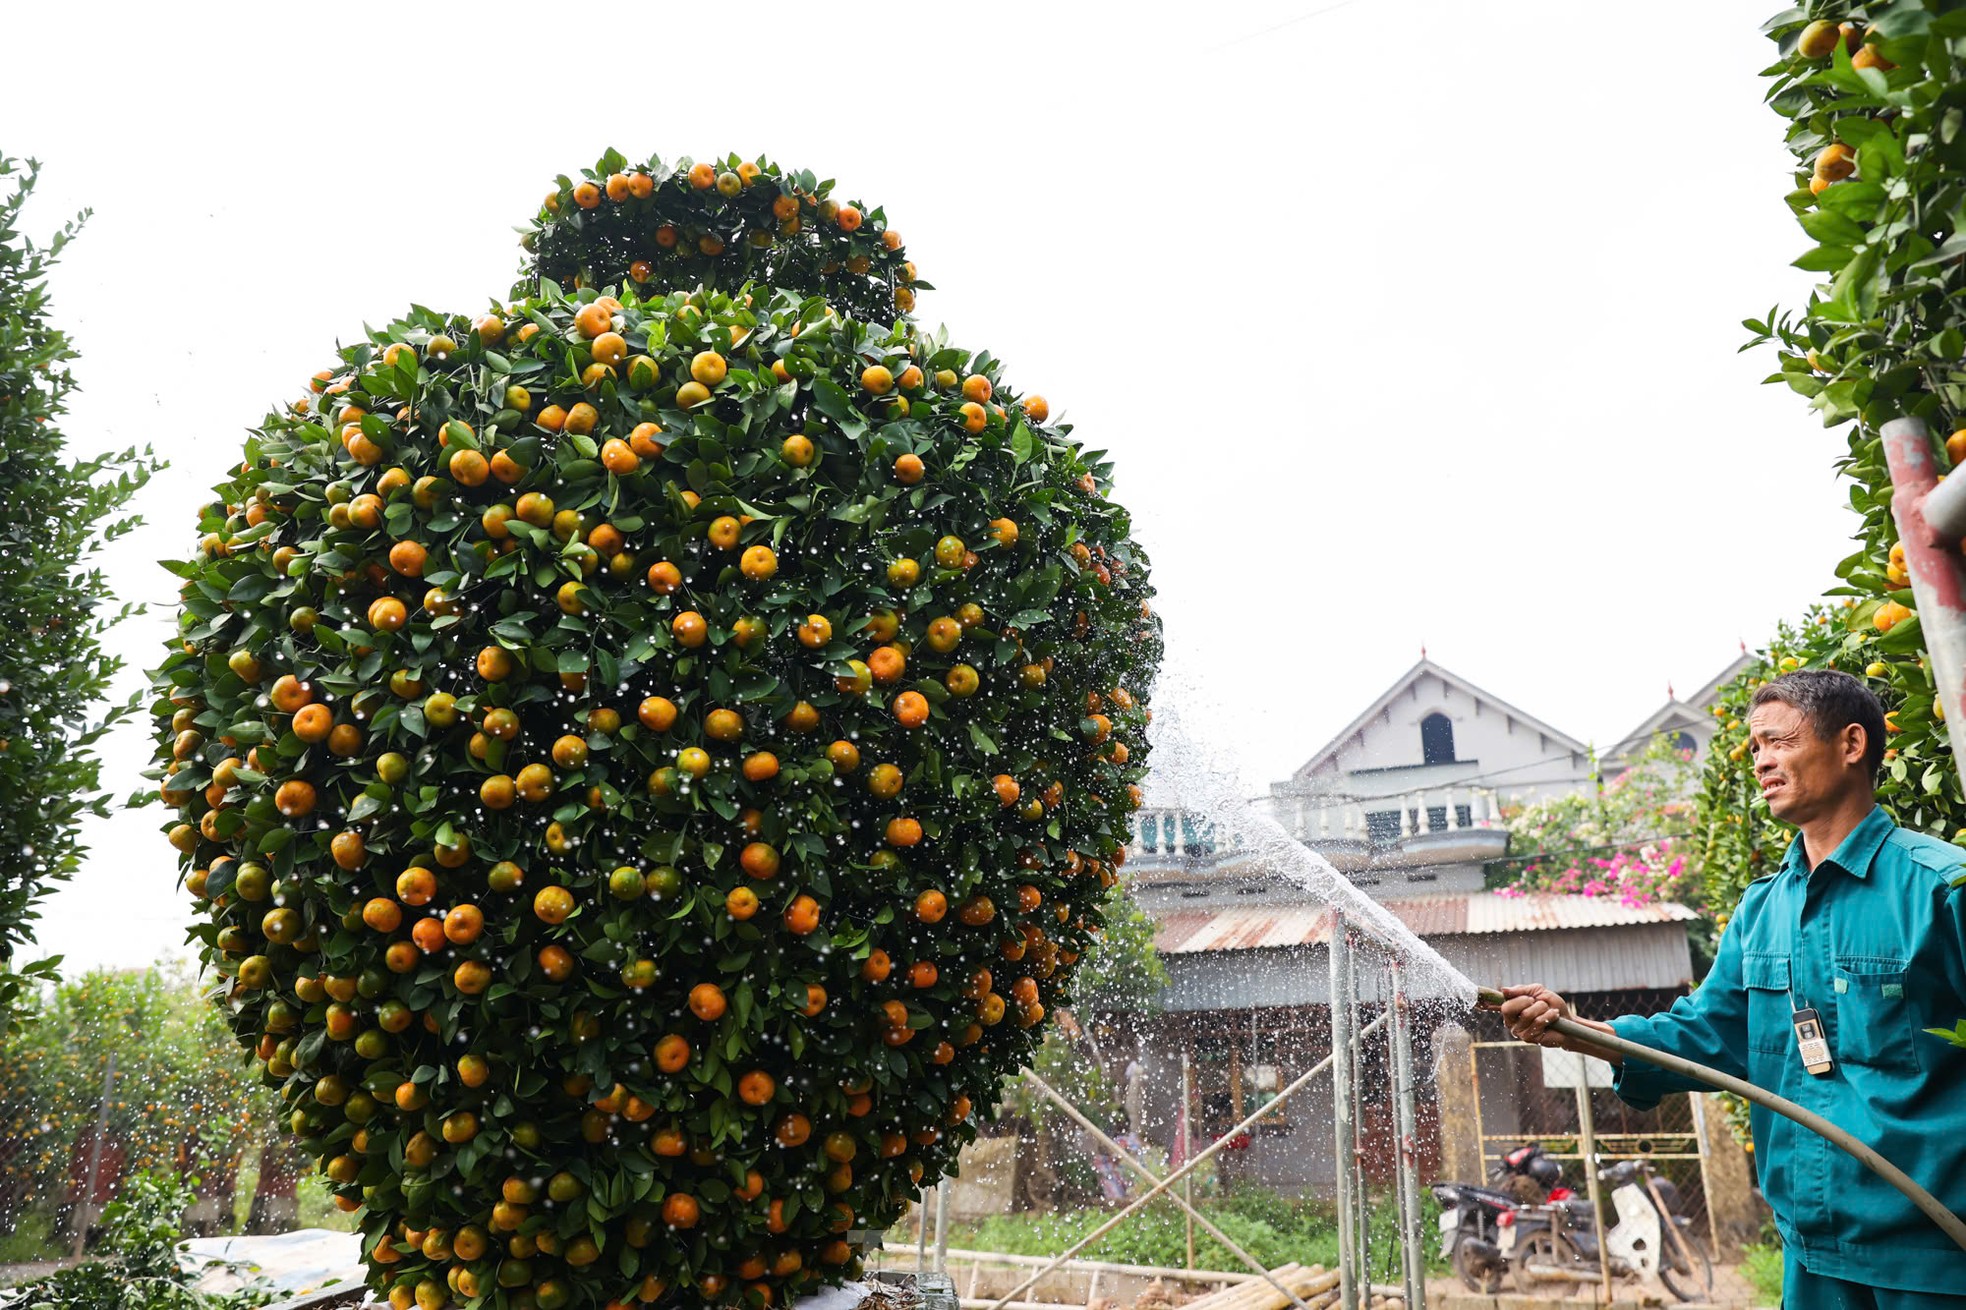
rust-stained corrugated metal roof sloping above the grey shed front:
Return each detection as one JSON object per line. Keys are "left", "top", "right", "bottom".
{"left": 1154, "top": 891, "right": 1699, "bottom": 956}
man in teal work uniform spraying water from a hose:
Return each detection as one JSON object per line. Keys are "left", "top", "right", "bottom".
{"left": 1502, "top": 669, "right": 1966, "bottom": 1310}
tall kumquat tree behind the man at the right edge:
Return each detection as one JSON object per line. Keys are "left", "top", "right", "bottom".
{"left": 1695, "top": 0, "right": 1966, "bottom": 1044}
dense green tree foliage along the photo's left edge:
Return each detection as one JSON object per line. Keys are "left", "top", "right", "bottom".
{"left": 0, "top": 155, "right": 157, "bottom": 1031}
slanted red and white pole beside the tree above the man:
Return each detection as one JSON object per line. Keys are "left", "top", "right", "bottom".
{"left": 1881, "top": 419, "right": 1966, "bottom": 763}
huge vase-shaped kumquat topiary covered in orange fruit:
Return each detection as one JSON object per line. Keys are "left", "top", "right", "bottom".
{"left": 155, "top": 153, "right": 1160, "bottom": 1310}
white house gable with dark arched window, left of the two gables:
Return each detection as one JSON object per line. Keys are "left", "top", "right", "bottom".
{"left": 1292, "top": 659, "right": 1589, "bottom": 789}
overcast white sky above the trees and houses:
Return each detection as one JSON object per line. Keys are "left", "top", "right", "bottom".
{"left": 0, "top": 0, "right": 1854, "bottom": 966}
